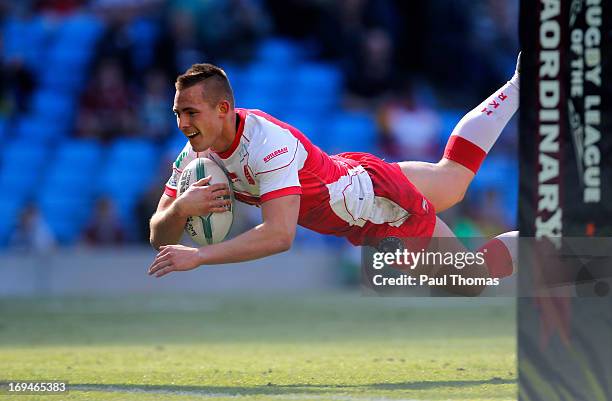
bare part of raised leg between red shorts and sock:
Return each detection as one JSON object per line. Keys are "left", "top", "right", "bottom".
{"left": 398, "top": 158, "right": 474, "bottom": 212}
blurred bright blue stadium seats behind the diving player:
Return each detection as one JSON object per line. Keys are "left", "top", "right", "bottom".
{"left": 0, "top": 6, "right": 517, "bottom": 246}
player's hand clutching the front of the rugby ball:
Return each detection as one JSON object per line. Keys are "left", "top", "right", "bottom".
{"left": 175, "top": 176, "right": 231, "bottom": 217}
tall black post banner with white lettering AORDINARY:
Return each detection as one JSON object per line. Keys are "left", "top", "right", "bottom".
{"left": 518, "top": 0, "right": 612, "bottom": 401}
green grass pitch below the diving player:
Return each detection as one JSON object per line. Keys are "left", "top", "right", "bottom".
{"left": 0, "top": 293, "right": 517, "bottom": 401}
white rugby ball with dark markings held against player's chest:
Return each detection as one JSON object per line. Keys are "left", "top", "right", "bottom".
{"left": 177, "top": 158, "right": 234, "bottom": 245}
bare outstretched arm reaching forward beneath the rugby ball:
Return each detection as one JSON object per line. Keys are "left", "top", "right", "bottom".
{"left": 149, "top": 195, "right": 300, "bottom": 277}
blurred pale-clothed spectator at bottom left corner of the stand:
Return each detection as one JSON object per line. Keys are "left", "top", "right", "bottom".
{"left": 9, "top": 204, "right": 56, "bottom": 253}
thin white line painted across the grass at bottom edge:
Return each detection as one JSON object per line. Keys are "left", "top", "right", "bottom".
{"left": 68, "top": 384, "right": 427, "bottom": 401}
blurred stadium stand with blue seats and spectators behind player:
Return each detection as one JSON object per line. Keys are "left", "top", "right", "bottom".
{"left": 0, "top": 0, "right": 518, "bottom": 290}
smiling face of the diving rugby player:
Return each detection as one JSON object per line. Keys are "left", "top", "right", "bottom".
{"left": 172, "top": 84, "right": 225, "bottom": 152}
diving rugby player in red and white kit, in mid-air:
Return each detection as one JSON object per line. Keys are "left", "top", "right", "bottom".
{"left": 149, "top": 57, "right": 519, "bottom": 292}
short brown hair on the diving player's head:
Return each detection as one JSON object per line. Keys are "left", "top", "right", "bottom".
{"left": 174, "top": 63, "right": 234, "bottom": 107}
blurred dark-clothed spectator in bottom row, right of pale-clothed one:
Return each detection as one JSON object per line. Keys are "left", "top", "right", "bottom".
{"left": 83, "top": 196, "right": 126, "bottom": 246}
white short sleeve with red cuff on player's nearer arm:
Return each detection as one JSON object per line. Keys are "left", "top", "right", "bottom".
{"left": 252, "top": 132, "right": 303, "bottom": 202}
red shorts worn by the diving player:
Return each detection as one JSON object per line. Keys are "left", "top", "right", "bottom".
{"left": 337, "top": 152, "right": 436, "bottom": 249}
